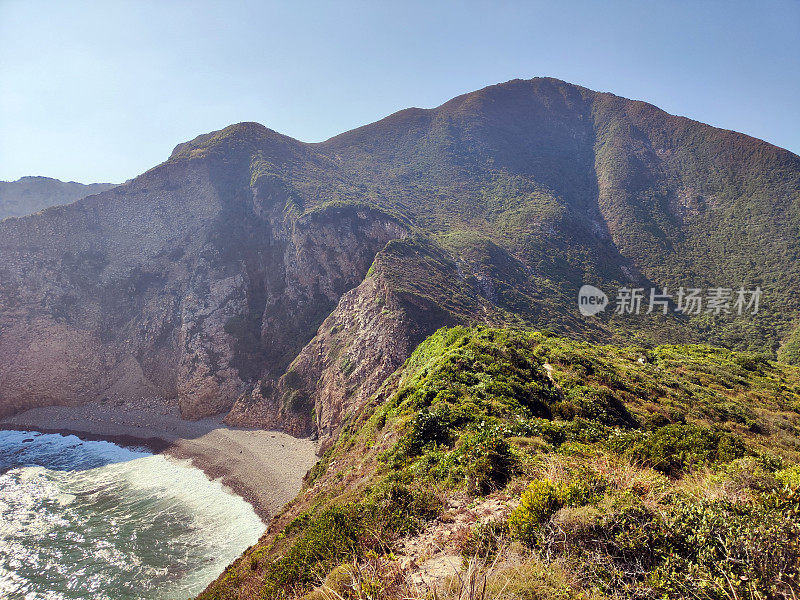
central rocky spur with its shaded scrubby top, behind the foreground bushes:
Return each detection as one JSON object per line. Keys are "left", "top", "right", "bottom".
{"left": 226, "top": 237, "right": 528, "bottom": 440}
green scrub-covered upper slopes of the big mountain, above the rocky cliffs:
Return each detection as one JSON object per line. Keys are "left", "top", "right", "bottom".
{"left": 171, "top": 78, "right": 800, "bottom": 370}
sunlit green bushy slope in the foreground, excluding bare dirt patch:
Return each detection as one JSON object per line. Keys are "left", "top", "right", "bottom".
{"left": 201, "top": 327, "right": 800, "bottom": 600}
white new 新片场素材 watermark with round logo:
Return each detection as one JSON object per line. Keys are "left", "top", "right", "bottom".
{"left": 578, "top": 285, "right": 763, "bottom": 317}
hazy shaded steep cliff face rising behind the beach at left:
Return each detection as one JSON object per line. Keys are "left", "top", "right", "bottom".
{"left": 0, "top": 132, "right": 405, "bottom": 418}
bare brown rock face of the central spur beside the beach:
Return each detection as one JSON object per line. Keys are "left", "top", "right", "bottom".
{"left": 226, "top": 275, "right": 457, "bottom": 439}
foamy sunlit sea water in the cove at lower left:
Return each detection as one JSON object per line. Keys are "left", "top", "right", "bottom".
{"left": 0, "top": 431, "right": 264, "bottom": 600}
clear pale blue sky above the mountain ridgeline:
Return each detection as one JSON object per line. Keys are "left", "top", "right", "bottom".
{"left": 0, "top": 0, "right": 800, "bottom": 182}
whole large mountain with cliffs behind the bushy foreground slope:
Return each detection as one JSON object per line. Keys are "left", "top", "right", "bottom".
{"left": 0, "top": 78, "right": 800, "bottom": 443}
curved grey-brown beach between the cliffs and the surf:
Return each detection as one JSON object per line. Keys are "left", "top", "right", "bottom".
{"left": 0, "top": 400, "right": 317, "bottom": 522}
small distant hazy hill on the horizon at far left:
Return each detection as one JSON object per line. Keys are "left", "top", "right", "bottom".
{"left": 0, "top": 177, "right": 114, "bottom": 219}
